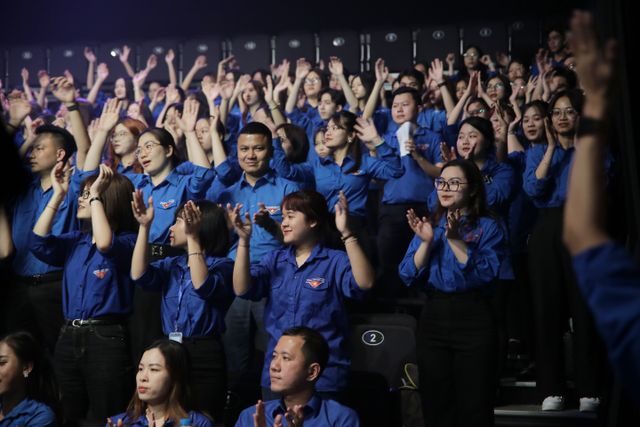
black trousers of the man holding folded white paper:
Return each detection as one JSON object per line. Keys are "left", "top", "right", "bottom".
{"left": 374, "top": 203, "right": 427, "bottom": 298}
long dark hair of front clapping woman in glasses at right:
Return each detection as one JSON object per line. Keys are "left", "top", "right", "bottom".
{"left": 431, "top": 159, "right": 490, "bottom": 224}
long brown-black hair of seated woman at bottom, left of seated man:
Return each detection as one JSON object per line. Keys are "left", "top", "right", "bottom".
{"left": 127, "top": 339, "right": 191, "bottom": 425}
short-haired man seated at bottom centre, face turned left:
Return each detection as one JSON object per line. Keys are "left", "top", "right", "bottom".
{"left": 236, "top": 326, "right": 360, "bottom": 427}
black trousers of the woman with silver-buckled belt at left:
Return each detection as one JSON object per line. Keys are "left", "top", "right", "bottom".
{"left": 54, "top": 324, "right": 135, "bottom": 426}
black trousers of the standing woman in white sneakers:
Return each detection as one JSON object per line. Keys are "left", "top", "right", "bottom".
{"left": 529, "top": 208, "right": 602, "bottom": 397}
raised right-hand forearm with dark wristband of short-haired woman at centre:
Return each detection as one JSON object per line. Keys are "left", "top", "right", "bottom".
{"left": 335, "top": 191, "right": 375, "bottom": 290}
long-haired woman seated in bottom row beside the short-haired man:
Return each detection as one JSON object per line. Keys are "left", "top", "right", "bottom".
{"left": 105, "top": 339, "right": 213, "bottom": 427}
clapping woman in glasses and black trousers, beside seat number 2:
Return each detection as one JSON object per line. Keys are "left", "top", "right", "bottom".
{"left": 399, "top": 160, "right": 508, "bottom": 427}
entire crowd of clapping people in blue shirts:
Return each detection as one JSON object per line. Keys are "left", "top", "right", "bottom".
{"left": 0, "top": 12, "right": 640, "bottom": 427}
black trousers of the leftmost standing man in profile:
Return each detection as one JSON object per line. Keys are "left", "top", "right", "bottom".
{"left": 3, "top": 273, "right": 64, "bottom": 355}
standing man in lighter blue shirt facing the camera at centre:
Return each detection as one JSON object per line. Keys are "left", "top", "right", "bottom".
{"left": 216, "top": 122, "right": 300, "bottom": 406}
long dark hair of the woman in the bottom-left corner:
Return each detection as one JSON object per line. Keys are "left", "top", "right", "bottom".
{"left": 0, "top": 331, "right": 60, "bottom": 418}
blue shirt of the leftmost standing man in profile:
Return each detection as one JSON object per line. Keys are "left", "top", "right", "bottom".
{"left": 11, "top": 170, "right": 96, "bottom": 276}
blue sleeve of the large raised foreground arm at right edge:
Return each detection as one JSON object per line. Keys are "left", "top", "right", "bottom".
{"left": 573, "top": 242, "right": 640, "bottom": 402}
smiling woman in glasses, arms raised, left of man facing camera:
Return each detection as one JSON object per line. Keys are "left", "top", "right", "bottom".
{"left": 85, "top": 100, "right": 215, "bottom": 368}
